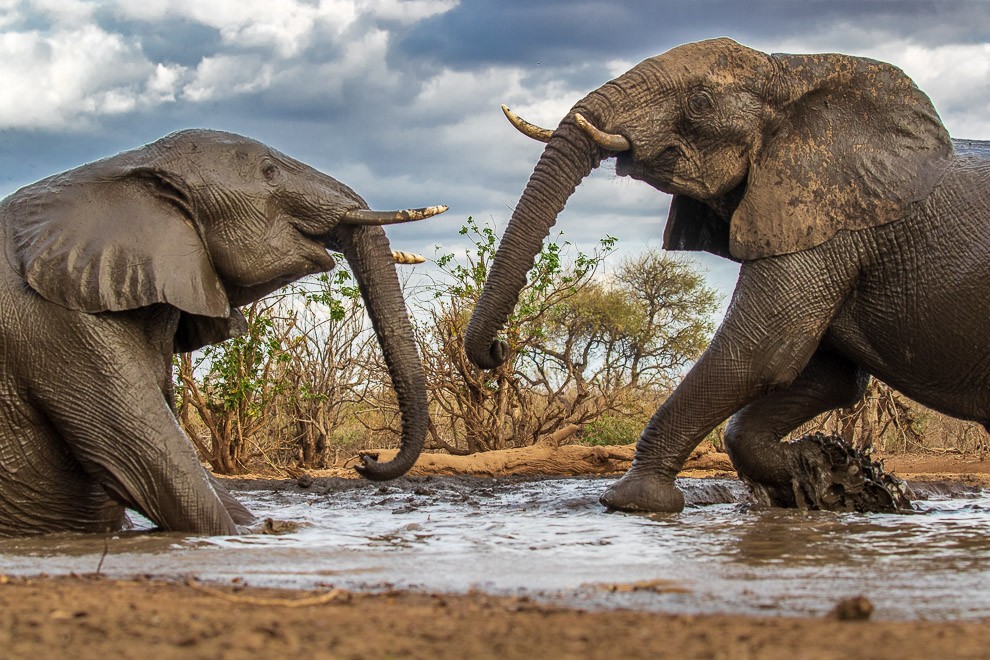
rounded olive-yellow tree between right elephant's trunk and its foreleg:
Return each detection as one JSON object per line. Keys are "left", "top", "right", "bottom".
{"left": 536, "top": 250, "right": 718, "bottom": 436}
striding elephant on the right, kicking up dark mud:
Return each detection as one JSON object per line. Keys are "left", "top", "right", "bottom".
{"left": 464, "top": 38, "right": 990, "bottom": 512}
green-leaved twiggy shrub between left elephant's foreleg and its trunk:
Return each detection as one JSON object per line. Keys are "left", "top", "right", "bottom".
{"left": 175, "top": 268, "right": 374, "bottom": 474}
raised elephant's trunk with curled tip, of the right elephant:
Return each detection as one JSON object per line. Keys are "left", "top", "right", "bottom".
{"left": 464, "top": 105, "right": 606, "bottom": 369}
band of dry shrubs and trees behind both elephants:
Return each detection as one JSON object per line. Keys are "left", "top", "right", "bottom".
{"left": 174, "top": 224, "right": 988, "bottom": 473}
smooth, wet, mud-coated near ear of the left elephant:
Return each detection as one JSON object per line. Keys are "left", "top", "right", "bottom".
{"left": 6, "top": 165, "right": 230, "bottom": 318}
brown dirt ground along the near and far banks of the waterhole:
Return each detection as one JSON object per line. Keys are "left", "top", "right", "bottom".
{"left": 0, "top": 446, "right": 990, "bottom": 659}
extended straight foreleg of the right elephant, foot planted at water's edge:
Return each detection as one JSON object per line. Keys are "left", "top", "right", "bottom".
{"left": 601, "top": 248, "right": 858, "bottom": 512}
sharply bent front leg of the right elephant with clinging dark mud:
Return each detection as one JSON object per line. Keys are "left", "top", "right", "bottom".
{"left": 725, "top": 351, "right": 907, "bottom": 511}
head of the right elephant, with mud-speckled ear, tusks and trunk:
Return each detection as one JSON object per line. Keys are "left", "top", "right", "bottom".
{"left": 465, "top": 39, "right": 952, "bottom": 368}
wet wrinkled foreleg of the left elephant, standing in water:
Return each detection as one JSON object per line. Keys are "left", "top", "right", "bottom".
{"left": 34, "top": 319, "right": 244, "bottom": 534}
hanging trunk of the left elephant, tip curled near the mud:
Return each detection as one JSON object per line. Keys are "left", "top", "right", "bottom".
{"left": 341, "top": 226, "right": 429, "bottom": 481}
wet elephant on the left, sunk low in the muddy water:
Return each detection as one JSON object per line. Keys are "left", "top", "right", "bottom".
{"left": 0, "top": 129, "right": 446, "bottom": 536}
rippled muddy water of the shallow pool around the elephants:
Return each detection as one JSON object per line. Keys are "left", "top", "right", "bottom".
{"left": 0, "top": 477, "right": 990, "bottom": 619}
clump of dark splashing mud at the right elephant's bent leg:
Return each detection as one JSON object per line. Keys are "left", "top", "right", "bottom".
{"left": 740, "top": 433, "right": 911, "bottom": 512}
